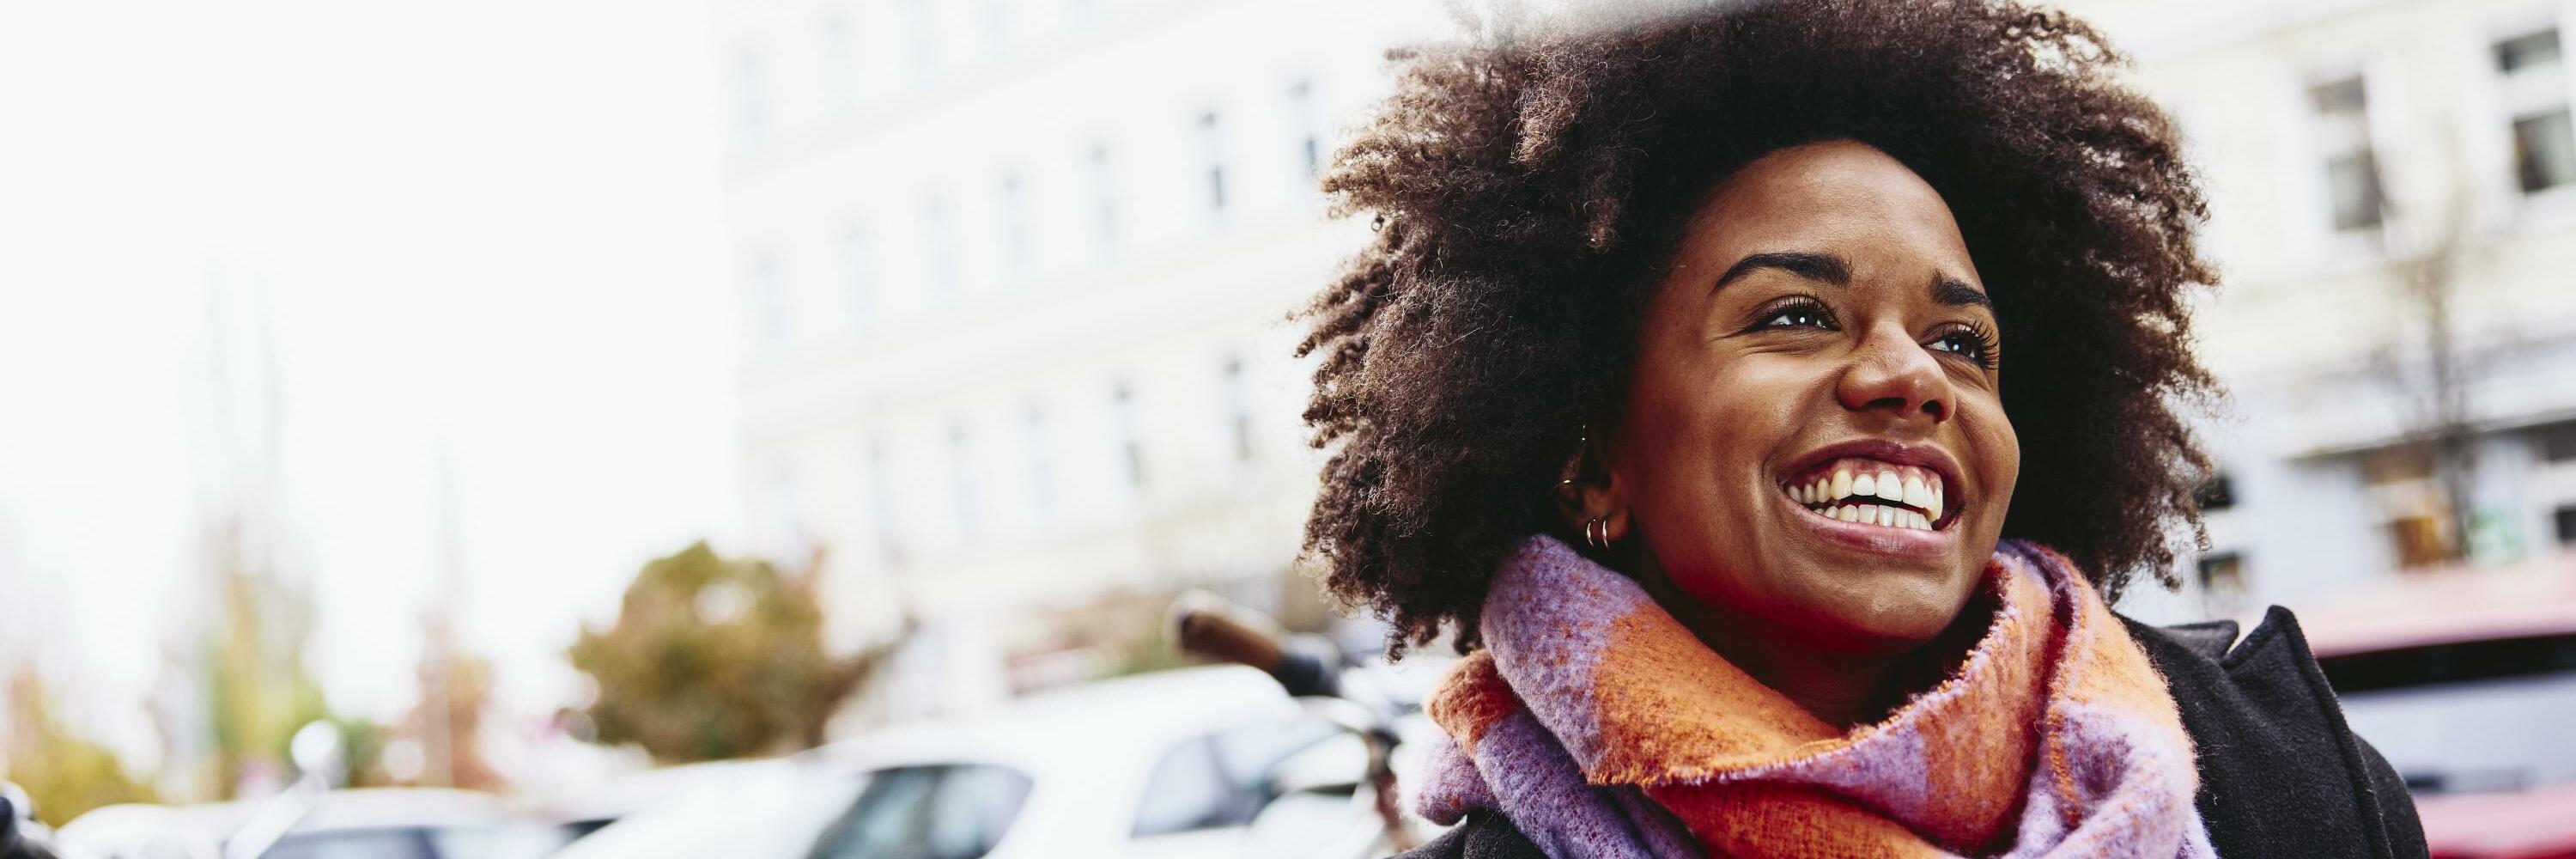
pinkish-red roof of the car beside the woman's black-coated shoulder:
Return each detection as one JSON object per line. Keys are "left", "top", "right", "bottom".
{"left": 2298, "top": 552, "right": 2576, "bottom": 658}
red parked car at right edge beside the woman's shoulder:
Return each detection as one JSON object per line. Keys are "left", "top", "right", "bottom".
{"left": 2303, "top": 555, "right": 2576, "bottom": 859}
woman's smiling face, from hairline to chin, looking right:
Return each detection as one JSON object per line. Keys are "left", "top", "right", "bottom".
{"left": 1607, "top": 139, "right": 2020, "bottom": 653}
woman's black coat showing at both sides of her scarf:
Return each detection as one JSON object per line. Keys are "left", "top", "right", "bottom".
{"left": 1404, "top": 606, "right": 2427, "bottom": 859}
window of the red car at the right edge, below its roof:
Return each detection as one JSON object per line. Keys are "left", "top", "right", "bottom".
{"left": 2318, "top": 626, "right": 2576, "bottom": 795}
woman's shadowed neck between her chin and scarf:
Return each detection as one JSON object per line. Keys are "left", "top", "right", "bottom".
{"left": 1638, "top": 562, "right": 1989, "bottom": 730}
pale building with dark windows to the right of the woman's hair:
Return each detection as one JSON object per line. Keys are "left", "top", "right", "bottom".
{"left": 2066, "top": 0, "right": 2576, "bottom": 619}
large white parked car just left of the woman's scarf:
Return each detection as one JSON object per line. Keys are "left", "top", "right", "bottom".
{"left": 559, "top": 666, "right": 1383, "bottom": 859}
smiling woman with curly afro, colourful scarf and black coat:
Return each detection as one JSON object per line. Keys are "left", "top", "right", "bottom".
{"left": 1303, "top": 0, "right": 2421, "bottom": 859}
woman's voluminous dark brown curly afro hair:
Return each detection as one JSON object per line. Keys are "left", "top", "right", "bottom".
{"left": 1298, "top": 0, "right": 2218, "bottom": 653}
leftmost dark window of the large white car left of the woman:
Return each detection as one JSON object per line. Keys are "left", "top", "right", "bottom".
{"left": 806, "top": 764, "right": 1030, "bottom": 859}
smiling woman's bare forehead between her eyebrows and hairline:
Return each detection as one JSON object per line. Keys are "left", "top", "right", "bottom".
{"left": 1680, "top": 139, "right": 1976, "bottom": 281}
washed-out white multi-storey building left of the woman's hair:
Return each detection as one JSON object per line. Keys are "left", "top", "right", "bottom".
{"left": 714, "top": 0, "right": 1445, "bottom": 699}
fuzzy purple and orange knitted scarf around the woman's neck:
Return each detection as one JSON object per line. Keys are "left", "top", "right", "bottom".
{"left": 1414, "top": 537, "right": 2215, "bottom": 859}
